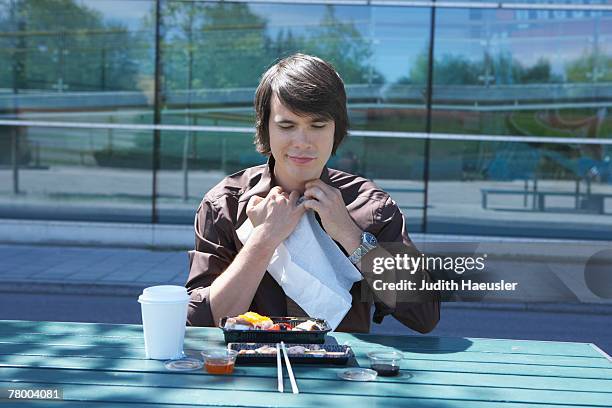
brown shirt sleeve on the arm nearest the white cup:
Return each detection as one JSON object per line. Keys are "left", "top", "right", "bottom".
{"left": 185, "top": 197, "right": 237, "bottom": 326}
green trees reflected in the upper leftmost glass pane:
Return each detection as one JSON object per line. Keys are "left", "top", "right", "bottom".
{"left": 0, "top": 0, "right": 138, "bottom": 91}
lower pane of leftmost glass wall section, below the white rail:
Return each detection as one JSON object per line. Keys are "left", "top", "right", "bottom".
{"left": 0, "top": 126, "right": 153, "bottom": 222}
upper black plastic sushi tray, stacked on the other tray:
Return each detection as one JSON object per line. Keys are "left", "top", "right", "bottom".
{"left": 219, "top": 317, "right": 331, "bottom": 344}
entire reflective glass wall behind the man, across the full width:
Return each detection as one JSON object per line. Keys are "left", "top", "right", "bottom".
{"left": 0, "top": 0, "right": 612, "bottom": 239}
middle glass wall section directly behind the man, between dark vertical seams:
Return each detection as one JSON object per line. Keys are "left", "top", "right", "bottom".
{"left": 155, "top": 1, "right": 430, "bottom": 228}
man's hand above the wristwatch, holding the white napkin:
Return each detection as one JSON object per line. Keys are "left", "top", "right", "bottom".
{"left": 303, "top": 179, "right": 362, "bottom": 255}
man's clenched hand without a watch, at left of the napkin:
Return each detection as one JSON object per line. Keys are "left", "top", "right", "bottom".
{"left": 246, "top": 186, "right": 306, "bottom": 249}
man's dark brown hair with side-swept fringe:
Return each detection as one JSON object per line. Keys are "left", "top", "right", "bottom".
{"left": 255, "top": 54, "right": 349, "bottom": 155}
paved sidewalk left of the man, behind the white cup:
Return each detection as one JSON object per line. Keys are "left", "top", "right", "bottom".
{"left": 0, "top": 245, "right": 189, "bottom": 296}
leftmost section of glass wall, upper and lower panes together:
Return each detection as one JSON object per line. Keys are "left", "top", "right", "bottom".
{"left": 0, "top": 0, "right": 155, "bottom": 222}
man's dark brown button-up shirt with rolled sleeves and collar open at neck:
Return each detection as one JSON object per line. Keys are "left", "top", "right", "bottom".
{"left": 186, "top": 158, "right": 440, "bottom": 333}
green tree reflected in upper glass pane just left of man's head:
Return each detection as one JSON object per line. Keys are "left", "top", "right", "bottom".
{"left": 163, "top": 3, "right": 270, "bottom": 90}
